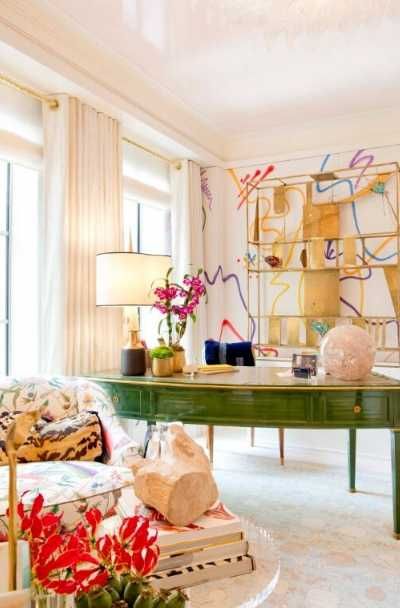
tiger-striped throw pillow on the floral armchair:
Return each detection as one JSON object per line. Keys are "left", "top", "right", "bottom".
{"left": 0, "top": 411, "right": 103, "bottom": 465}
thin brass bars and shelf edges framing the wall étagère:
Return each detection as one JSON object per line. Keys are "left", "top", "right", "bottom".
{"left": 244, "top": 161, "right": 400, "bottom": 366}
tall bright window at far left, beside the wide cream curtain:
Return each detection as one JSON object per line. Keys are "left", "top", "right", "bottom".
{"left": 0, "top": 160, "right": 40, "bottom": 375}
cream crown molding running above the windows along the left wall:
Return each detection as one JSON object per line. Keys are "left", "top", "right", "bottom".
{"left": 0, "top": 0, "right": 223, "bottom": 161}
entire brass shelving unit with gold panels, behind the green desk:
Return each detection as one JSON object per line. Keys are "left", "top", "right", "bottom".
{"left": 245, "top": 163, "right": 400, "bottom": 364}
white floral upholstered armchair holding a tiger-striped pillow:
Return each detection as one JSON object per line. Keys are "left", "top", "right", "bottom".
{"left": 0, "top": 377, "right": 138, "bottom": 538}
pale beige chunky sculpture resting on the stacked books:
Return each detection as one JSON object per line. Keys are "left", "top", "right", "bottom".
{"left": 131, "top": 423, "right": 218, "bottom": 526}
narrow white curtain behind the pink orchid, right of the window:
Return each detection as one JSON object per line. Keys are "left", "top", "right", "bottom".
{"left": 171, "top": 160, "right": 207, "bottom": 363}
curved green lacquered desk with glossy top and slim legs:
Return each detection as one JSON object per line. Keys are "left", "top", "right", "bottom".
{"left": 90, "top": 367, "right": 400, "bottom": 538}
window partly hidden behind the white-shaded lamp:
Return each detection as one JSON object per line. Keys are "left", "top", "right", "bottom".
{"left": 124, "top": 196, "right": 171, "bottom": 347}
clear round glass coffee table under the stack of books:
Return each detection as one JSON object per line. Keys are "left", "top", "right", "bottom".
{"left": 187, "top": 520, "right": 280, "bottom": 608}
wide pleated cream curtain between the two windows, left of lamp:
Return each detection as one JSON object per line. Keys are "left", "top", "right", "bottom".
{"left": 39, "top": 96, "right": 122, "bottom": 375}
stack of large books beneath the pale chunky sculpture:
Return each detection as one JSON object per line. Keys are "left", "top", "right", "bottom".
{"left": 119, "top": 494, "right": 255, "bottom": 589}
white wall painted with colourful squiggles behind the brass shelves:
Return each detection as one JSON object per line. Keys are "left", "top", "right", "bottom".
{"left": 203, "top": 146, "right": 400, "bottom": 362}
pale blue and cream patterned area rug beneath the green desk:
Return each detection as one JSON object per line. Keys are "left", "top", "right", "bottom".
{"left": 214, "top": 442, "right": 400, "bottom": 608}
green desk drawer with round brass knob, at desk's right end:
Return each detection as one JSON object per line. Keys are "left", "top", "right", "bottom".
{"left": 323, "top": 392, "right": 391, "bottom": 428}
